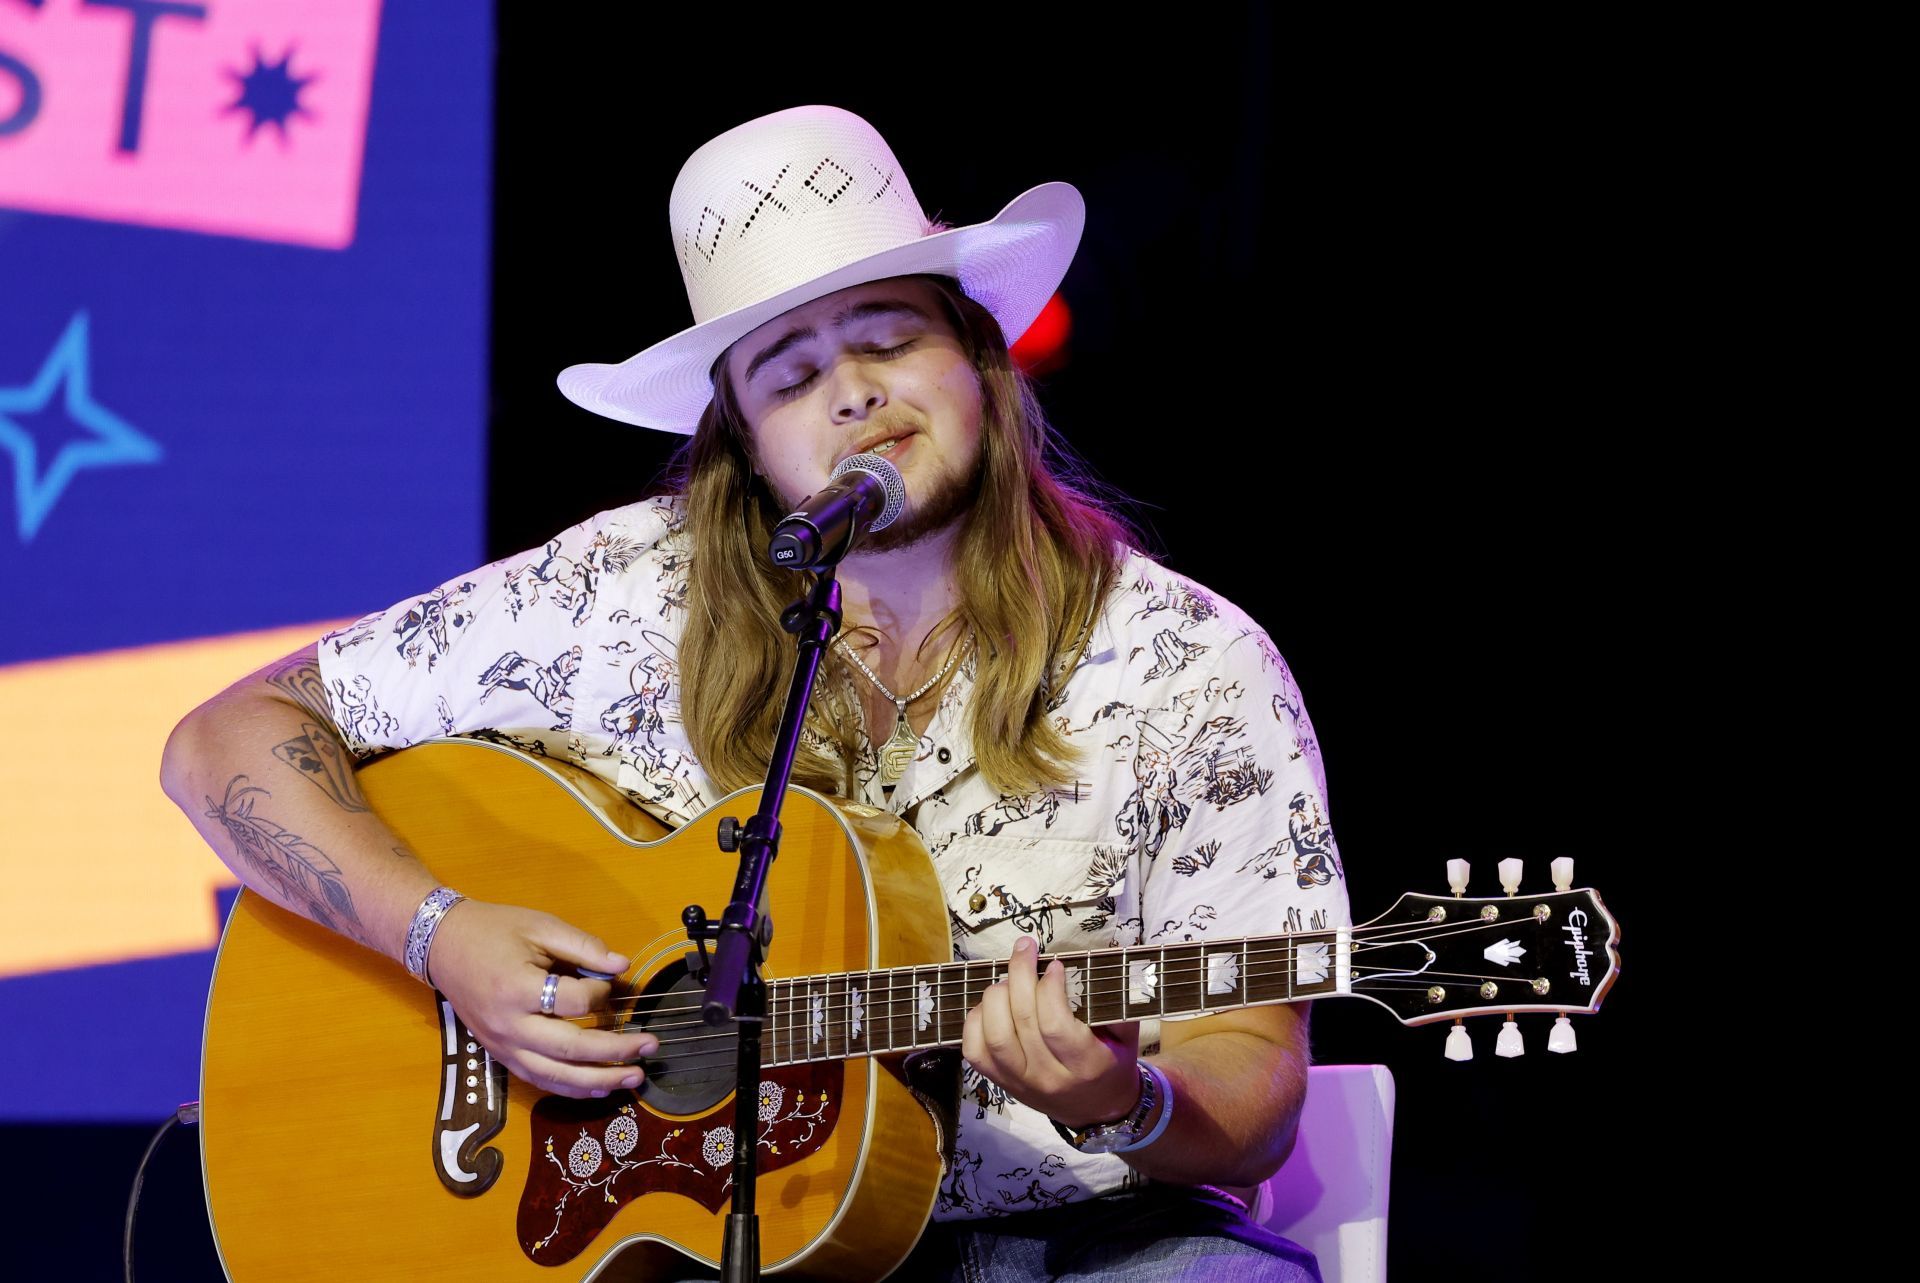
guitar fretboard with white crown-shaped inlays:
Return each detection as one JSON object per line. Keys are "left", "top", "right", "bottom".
{"left": 762, "top": 932, "right": 1344, "bottom": 1066}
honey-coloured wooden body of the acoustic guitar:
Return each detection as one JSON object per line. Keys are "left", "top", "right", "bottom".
{"left": 202, "top": 739, "right": 950, "bottom": 1283}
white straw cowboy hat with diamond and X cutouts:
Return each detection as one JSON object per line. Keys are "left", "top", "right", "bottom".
{"left": 559, "top": 108, "right": 1087, "bottom": 434}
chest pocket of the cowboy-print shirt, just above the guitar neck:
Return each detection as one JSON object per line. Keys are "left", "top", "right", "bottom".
{"left": 939, "top": 834, "right": 1127, "bottom": 958}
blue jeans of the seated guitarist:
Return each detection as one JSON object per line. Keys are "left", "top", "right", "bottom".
{"left": 893, "top": 1185, "right": 1321, "bottom": 1283}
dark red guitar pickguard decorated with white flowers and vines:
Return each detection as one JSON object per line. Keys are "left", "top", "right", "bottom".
{"left": 516, "top": 1060, "right": 845, "bottom": 1266}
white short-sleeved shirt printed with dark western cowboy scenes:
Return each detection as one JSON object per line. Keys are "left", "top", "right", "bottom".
{"left": 321, "top": 499, "right": 1352, "bottom": 1220}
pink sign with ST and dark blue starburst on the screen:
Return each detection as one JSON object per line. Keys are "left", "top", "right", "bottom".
{"left": 0, "top": 0, "right": 380, "bottom": 250}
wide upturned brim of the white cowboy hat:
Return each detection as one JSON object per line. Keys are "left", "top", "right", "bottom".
{"left": 559, "top": 182, "right": 1087, "bottom": 436}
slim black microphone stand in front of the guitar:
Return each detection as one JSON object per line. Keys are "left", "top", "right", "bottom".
{"left": 682, "top": 556, "right": 852, "bottom": 1283}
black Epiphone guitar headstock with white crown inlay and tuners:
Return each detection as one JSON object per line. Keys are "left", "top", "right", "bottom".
{"left": 1350, "top": 889, "right": 1620, "bottom": 1026}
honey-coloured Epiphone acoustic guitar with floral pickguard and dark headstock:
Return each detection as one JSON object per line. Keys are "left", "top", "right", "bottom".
{"left": 202, "top": 739, "right": 1619, "bottom": 1283}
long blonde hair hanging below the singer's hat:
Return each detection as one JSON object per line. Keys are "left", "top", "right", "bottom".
{"left": 668, "top": 277, "right": 1137, "bottom": 795}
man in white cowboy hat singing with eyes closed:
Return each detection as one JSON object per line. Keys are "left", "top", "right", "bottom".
{"left": 163, "top": 108, "right": 1350, "bottom": 1279}
